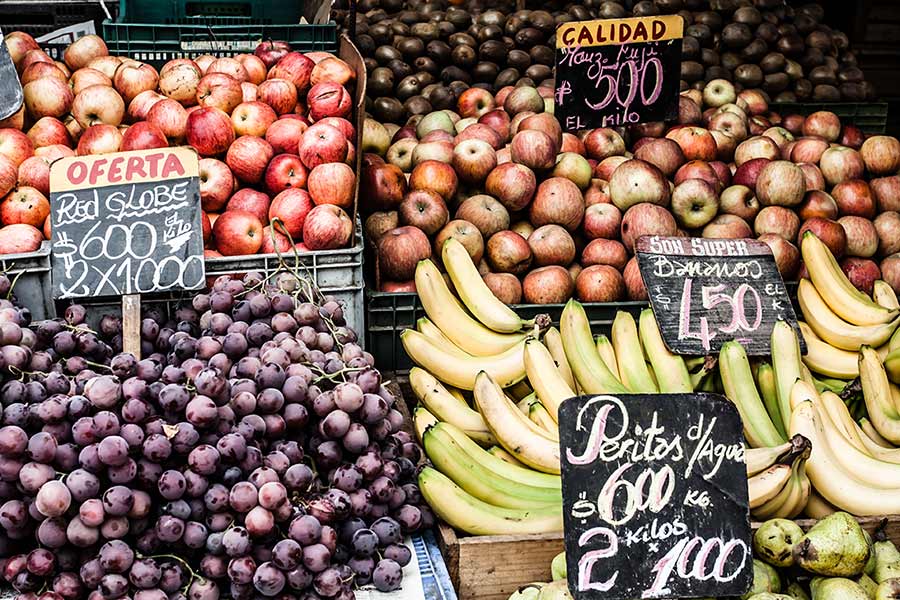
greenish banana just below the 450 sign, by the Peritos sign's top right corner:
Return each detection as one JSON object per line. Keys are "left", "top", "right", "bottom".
{"left": 719, "top": 341, "right": 786, "bottom": 448}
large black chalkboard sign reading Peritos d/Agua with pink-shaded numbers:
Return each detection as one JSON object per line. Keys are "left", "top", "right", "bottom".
{"left": 559, "top": 394, "right": 753, "bottom": 600}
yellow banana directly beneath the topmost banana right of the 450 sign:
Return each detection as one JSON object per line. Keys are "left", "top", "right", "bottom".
{"left": 797, "top": 279, "right": 898, "bottom": 351}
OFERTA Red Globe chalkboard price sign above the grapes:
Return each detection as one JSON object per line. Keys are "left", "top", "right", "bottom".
{"left": 50, "top": 148, "right": 206, "bottom": 298}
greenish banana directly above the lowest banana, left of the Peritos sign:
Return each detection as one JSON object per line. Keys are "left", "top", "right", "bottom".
{"left": 423, "top": 428, "right": 562, "bottom": 508}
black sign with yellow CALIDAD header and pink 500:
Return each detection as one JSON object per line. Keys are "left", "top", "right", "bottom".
{"left": 554, "top": 15, "right": 684, "bottom": 131}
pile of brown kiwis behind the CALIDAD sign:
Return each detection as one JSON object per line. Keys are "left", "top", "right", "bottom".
{"left": 338, "top": 0, "right": 875, "bottom": 125}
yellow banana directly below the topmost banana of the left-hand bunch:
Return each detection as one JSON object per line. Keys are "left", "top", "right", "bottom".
{"left": 416, "top": 260, "right": 526, "bottom": 356}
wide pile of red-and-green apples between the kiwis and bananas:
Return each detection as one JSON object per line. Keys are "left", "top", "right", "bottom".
{"left": 360, "top": 80, "right": 900, "bottom": 304}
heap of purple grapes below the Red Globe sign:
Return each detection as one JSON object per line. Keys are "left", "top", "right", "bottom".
{"left": 0, "top": 273, "right": 434, "bottom": 600}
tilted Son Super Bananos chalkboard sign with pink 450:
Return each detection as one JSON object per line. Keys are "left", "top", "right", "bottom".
{"left": 635, "top": 236, "right": 806, "bottom": 356}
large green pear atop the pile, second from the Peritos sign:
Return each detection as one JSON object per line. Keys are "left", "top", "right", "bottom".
{"left": 793, "top": 512, "right": 870, "bottom": 576}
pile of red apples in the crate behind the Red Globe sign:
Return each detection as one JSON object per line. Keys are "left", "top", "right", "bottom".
{"left": 0, "top": 32, "right": 356, "bottom": 257}
